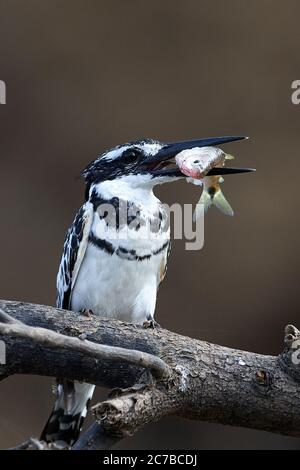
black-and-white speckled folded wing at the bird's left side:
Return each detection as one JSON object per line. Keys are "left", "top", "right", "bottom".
{"left": 56, "top": 202, "right": 94, "bottom": 309}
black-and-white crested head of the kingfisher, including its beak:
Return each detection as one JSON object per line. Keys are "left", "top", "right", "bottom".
{"left": 82, "top": 136, "right": 253, "bottom": 196}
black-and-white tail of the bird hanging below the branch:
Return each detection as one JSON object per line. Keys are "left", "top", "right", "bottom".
{"left": 41, "top": 380, "right": 95, "bottom": 447}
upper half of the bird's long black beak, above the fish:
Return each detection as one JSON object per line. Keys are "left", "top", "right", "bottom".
{"left": 147, "top": 135, "right": 248, "bottom": 163}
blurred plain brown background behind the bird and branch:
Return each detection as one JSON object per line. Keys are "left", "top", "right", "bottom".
{"left": 0, "top": 0, "right": 300, "bottom": 449}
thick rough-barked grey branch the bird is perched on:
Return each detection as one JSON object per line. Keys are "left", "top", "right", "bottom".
{"left": 0, "top": 301, "right": 300, "bottom": 448}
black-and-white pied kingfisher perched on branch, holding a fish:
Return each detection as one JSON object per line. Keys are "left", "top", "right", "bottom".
{"left": 42, "top": 136, "right": 251, "bottom": 445}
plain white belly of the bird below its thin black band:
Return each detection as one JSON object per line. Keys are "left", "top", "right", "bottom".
{"left": 71, "top": 244, "right": 165, "bottom": 323}
